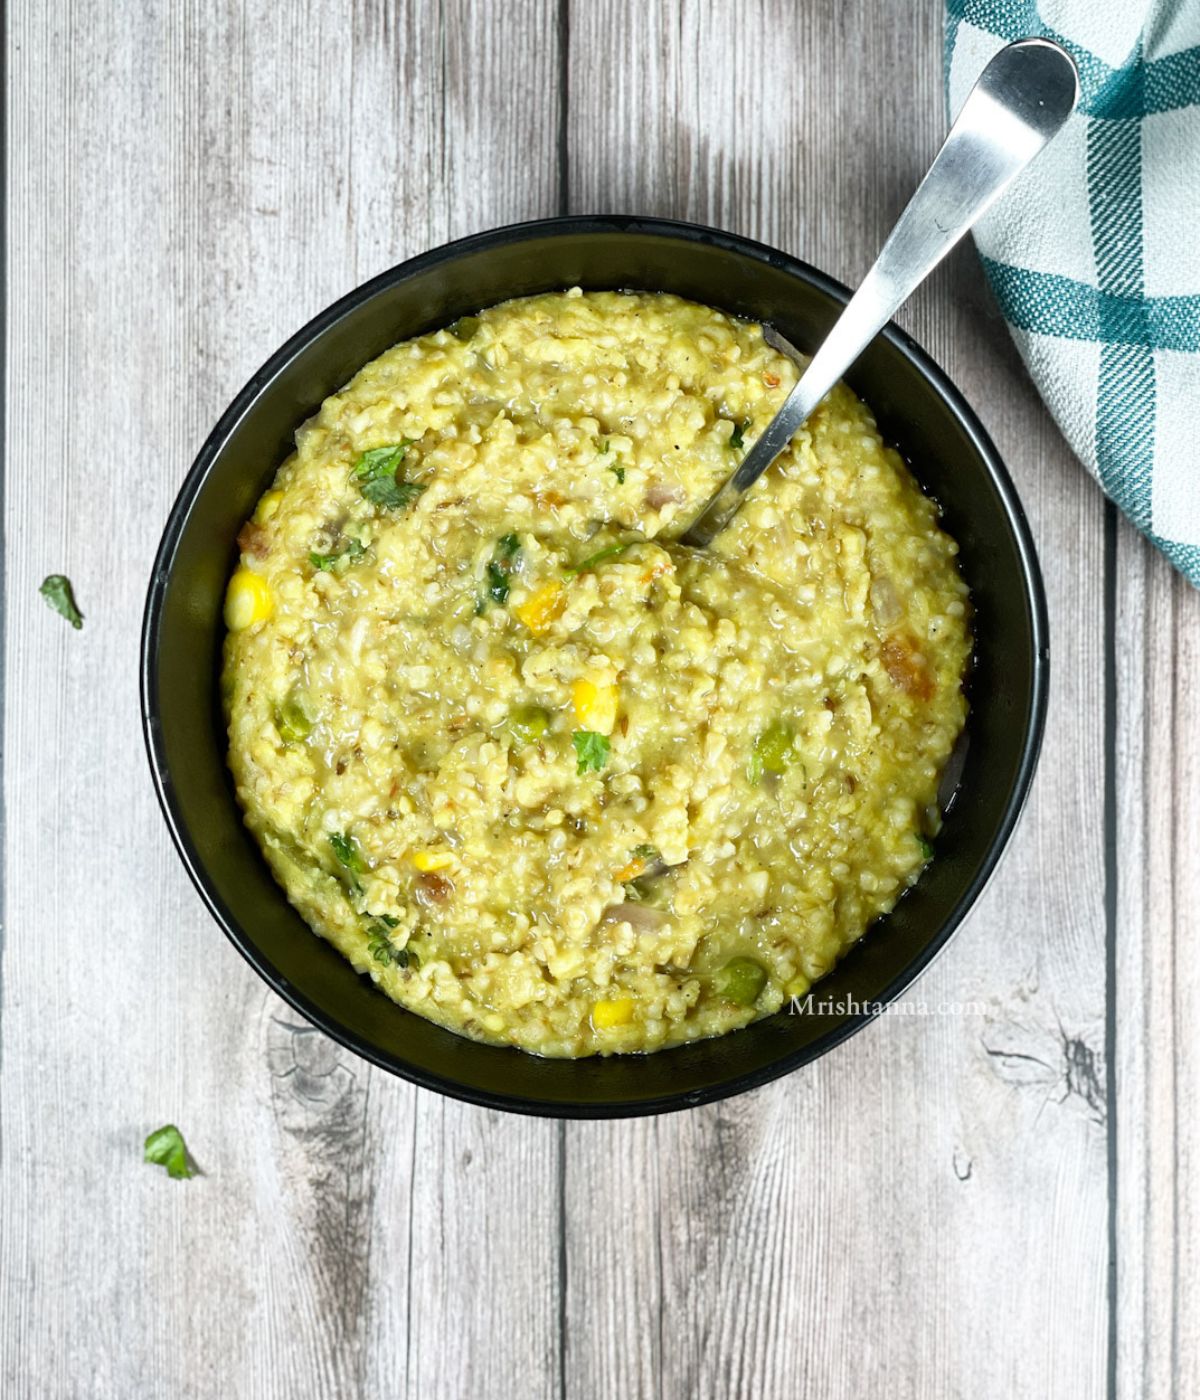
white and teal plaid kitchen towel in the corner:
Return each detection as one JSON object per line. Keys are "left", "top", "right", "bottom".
{"left": 945, "top": 0, "right": 1200, "bottom": 585}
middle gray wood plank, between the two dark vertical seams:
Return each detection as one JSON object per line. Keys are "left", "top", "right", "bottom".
{"left": 566, "top": 0, "right": 1106, "bottom": 1397}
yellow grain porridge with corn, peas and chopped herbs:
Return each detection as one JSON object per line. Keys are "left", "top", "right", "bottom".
{"left": 223, "top": 290, "right": 970, "bottom": 1056}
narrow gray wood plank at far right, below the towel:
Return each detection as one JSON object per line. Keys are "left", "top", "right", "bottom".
{"left": 1113, "top": 522, "right": 1200, "bottom": 1400}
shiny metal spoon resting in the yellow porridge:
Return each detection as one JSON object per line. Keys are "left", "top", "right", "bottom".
{"left": 682, "top": 39, "right": 1080, "bottom": 547}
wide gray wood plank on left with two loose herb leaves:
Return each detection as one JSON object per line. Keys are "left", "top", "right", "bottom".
{"left": 0, "top": 0, "right": 559, "bottom": 1400}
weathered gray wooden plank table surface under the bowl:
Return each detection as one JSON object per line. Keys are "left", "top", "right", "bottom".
{"left": 0, "top": 0, "right": 1200, "bottom": 1400}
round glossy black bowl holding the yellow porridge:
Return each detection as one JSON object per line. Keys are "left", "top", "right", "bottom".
{"left": 141, "top": 218, "right": 1049, "bottom": 1117}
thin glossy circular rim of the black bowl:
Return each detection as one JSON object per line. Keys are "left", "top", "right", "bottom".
{"left": 139, "top": 214, "right": 1050, "bottom": 1119}
